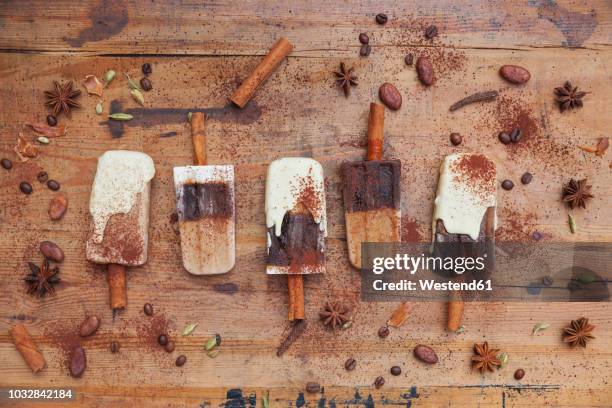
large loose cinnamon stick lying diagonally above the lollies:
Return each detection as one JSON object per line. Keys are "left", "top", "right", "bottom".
{"left": 230, "top": 37, "right": 293, "bottom": 108}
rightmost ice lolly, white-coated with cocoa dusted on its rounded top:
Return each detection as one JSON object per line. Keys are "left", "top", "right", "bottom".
{"left": 432, "top": 153, "right": 497, "bottom": 332}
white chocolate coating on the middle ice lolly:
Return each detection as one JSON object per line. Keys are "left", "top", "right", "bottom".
{"left": 266, "top": 157, "right": 327, "bottom": 247}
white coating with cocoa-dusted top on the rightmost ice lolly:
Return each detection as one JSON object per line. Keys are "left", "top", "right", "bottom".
{"left": 432, "top": 153, "right": 497, "bottom": 241}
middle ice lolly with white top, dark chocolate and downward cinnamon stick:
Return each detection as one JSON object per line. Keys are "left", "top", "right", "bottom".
{"left": 265, "top": 157, "right": 327, "bottom": 320}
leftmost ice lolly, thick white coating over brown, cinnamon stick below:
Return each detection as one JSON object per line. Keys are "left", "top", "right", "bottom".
{"left": 86, "top": 150, "right": 155, "bottom": 310}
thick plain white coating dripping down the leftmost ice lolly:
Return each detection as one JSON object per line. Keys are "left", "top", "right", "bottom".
{"left": 89, "top": 150, "right": 155, "bottom": 244}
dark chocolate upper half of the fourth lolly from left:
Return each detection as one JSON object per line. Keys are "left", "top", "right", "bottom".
{"left": 342, "top": 160, "right": 401, "bottom": 212}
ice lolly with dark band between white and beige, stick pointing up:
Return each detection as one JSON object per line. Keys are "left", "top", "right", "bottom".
{"left": 174, "top": 112, "right": 236, "bottom": 275}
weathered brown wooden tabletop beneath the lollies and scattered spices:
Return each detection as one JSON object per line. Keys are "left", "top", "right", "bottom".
{"left": 0, "top": 0, "right": 612, "bottom": 407}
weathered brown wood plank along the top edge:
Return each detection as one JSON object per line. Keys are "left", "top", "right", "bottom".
{"left": 0, "top": 0, "right": 612, "bottom": 57}
